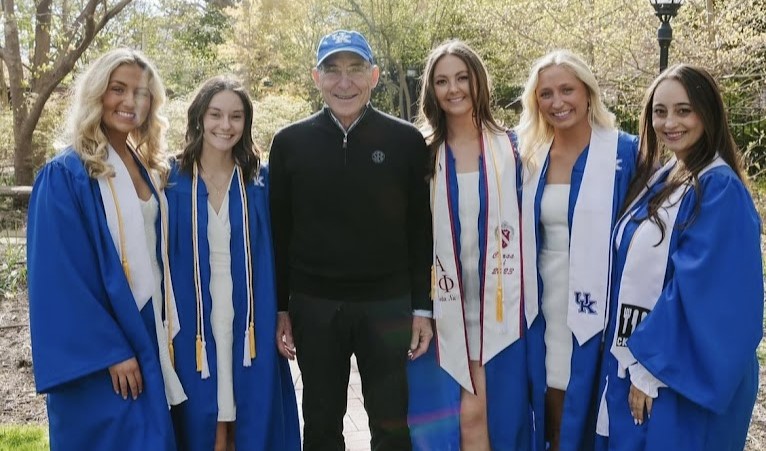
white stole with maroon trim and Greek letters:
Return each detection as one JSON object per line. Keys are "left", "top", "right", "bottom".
{"left": 431, "top": 131, "right": 523, "bottom": 393}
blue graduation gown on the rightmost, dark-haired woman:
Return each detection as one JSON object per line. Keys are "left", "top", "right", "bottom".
{"left": 602, "top": 166, "right": 763, "bottom": 451}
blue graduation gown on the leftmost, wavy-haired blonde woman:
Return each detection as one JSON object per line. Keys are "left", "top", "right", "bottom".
{"left": 27, "top": 149, "right": 175, "bottom": 451}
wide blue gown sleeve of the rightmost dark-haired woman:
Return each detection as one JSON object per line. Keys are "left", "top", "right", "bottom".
{"left": 628, "top": 170, "right": 763, "bottom": 414}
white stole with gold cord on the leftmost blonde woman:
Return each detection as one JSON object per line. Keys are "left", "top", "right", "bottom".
{"left": 97, "top": 146, "right": 187, "bottom": 405}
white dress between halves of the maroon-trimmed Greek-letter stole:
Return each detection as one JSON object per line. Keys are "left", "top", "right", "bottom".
{"left": 457, "top": 171, "right": 481, "bottom": 360}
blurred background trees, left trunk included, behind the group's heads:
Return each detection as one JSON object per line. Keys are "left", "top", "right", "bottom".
{"left": 0, "top": 0, "right": 766, "bottom": 180}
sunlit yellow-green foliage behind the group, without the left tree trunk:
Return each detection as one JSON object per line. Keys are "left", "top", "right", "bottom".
{"left": 0, "top": 0, "right": 766, "bottom": 182}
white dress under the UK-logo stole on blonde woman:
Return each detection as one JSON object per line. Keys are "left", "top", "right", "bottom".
{"left": 538, "top": 184, "right": 572, "bottom": 390}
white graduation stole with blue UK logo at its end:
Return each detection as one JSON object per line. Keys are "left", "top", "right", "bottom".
{"left": 522, "top": 127, "right": 619, "bottom": 345}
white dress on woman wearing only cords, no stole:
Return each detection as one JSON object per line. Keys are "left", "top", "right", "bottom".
{"left": 207, "top": 193, "right": 237, "bottom": 421}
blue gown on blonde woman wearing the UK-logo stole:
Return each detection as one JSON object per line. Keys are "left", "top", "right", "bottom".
{"left": 524, "top": 132, "right": 638, "bottom": 451}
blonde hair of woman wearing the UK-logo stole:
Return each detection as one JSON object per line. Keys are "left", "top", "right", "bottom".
{"left": 516, "top": 50, "right": 615, "bottom": 171}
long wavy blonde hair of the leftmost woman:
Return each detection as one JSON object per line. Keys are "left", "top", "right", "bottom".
{"left": 63, "top": 48, "right": 170, "bottom": 184}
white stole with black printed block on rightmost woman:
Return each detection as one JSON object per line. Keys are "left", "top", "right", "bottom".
{"left": 611, "top": 157, "right": 726, "bottom": 378}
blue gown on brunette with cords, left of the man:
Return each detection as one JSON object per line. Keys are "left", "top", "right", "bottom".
{"left": 166, "top": 166, "right": 300, "bottom": 451}
